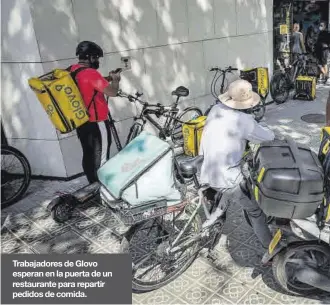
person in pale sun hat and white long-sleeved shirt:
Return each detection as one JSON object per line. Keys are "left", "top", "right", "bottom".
{"left": 200, "top": 80, "right": 275, "bottom": 262}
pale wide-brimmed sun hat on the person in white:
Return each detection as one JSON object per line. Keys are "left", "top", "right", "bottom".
{"left": 218, "top": 79, "right": 260, "bottom": 110}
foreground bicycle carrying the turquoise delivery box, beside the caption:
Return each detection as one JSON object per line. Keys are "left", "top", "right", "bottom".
{"left": 120, "top": 150, "right": 255, "bottom": 292}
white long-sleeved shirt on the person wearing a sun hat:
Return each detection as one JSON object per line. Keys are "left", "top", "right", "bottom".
{"left": 199, "top": 103, "right": 275, "bottom": 189}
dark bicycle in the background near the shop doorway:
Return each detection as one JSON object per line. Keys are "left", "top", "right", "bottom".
{"left": 270, "top": 53, "right": 317, "bottom": 104}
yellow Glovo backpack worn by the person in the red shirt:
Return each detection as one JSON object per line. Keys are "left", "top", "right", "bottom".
{"left": 28, "top": 67, "right": 90, "bottom": 133}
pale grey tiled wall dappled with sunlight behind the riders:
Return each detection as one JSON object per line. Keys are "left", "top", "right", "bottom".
{"left": 1, "top": 0, "right": 273, "bottom": 177}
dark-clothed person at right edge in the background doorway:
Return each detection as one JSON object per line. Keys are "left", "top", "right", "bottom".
{"left": 315, "top": 21, "right": 330, "bottom": 83}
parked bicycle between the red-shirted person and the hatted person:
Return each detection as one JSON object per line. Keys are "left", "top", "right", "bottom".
{"left": 118, "top": 86, "right": 203, "bottom": 147}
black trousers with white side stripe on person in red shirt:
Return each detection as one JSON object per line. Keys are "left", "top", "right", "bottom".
{"left": 77, "top": 121, "right": 111, "bottom": 183}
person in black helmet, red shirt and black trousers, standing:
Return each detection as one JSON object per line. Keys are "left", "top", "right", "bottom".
{"left": 70, "top": 41, "right": 120, "bottom": 183}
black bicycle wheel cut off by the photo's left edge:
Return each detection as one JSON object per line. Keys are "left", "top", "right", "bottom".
{"left": 1, "top": 145, "right": 31, "bottom": 209}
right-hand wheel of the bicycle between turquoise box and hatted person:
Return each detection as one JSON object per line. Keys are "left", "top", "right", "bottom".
{"left": 171, "top": 107, "right": 203, "bottom": 146}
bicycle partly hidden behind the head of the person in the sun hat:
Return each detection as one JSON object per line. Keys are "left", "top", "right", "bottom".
{"left": 204, "top": 66, "right": 267, "bottom": 122}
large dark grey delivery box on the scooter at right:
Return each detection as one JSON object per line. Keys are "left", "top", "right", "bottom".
{"left": 251, "top": 139, "right": 324, "bottom": 219}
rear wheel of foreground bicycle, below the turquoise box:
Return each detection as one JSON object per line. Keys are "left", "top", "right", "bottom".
{"left": 121, "top": 209, "right": 202, "bottom": 292}
